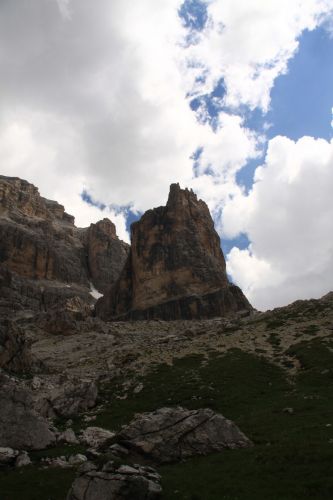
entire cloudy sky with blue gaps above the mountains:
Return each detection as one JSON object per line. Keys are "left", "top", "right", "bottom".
{"left": 0, "top": 0, "right": 333, "bottom": 309}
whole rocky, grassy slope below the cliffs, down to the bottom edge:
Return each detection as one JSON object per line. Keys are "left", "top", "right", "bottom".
{"left": 0, "top": 293, "right": 333, "bottom": 500}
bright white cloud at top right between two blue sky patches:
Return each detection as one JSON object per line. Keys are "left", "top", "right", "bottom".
{"left": 184, "top": 0, "right": 333, "bottom": 111}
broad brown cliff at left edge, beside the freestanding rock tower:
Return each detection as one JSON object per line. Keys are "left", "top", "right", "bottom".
{"left": 0, "top": 176, "right": 129, "bottom": 315}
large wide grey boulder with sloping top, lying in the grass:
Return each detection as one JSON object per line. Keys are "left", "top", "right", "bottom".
{"left": 115, "top": 407, "right": 252, "bottom": 464}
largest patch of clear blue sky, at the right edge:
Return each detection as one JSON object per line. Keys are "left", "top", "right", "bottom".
{"left": 266, "top": 27, "right": 333, "bottom": 140}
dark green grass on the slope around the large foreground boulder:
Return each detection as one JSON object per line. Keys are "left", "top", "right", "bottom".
{"left": 0, "top": 340, "right": 333, "bottom": 500}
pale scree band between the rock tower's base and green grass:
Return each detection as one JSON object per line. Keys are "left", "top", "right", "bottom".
{"left": 29, "top": 293, "right": 333, "bottom": 379}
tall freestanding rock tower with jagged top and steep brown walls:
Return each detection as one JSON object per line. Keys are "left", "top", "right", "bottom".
{"left": 96, "top": 184, "right": 251, "bottom": 319}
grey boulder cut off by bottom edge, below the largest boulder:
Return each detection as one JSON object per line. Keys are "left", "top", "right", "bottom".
{"left": 67, "top": 463, "right": 162, "bottom": 500}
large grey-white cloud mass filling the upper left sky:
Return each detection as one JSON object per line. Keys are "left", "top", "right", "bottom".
{"left": 0, "top": 0, "right": 197, "bottom": 223}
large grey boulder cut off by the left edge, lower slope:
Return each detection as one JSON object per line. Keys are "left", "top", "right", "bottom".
{"left": 0, "top": 377, "right": 55, "bottom": 450}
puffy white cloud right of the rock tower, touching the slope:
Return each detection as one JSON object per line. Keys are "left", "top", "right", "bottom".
{"left": 223, "top": 136, "right": 333, "bottom": 309}
